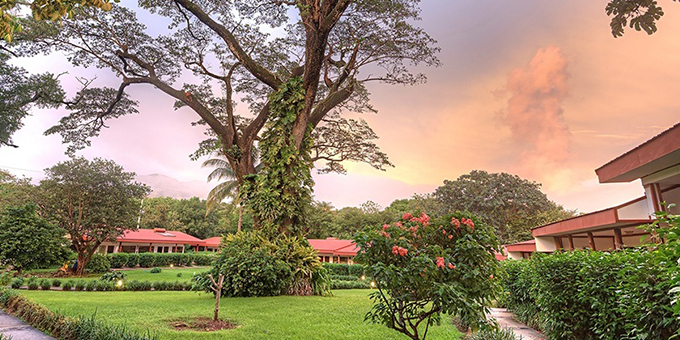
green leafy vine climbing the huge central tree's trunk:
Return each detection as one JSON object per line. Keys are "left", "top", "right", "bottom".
{"left": 240, "top": 78, "right": 314, "bottom": 233}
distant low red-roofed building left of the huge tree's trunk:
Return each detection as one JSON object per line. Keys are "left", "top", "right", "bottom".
{"left": 99, "top": 228, "right": 204, "bottom": 254}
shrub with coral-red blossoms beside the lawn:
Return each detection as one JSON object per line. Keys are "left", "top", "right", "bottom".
{"left": 355, "top": 213, "right": 500, "bottom": 339}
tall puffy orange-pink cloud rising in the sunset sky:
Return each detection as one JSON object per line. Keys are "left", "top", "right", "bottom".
{"left": 500, "top": 46, "right": 571, "bottom": 190}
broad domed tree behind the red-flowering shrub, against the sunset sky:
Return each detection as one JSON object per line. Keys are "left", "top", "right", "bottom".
{"left": 434, "top": 170, "right": 575, "bottom": 243}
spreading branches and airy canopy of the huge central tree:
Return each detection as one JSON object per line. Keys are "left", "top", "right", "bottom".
{"left": 20, "top": 0, "right": 439, "bottom": 232}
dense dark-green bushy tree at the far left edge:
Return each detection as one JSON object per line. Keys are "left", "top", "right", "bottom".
{"left": 0, "top": 204, "right": 69, "bottom": 273}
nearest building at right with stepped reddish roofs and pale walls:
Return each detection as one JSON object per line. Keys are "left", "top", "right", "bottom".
{"left": 505, "top": 123, "right": 680, "bottom": 259}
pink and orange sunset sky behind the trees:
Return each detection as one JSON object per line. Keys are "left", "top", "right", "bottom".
{"left": 0, "top": 0, "right": 680, "bottom": 212}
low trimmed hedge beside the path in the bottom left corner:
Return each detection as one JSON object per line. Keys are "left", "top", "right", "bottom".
{"left": 0, "top": 288, "right": 158, "bottom": 340}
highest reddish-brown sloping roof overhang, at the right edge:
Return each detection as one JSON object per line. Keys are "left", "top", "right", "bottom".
{"left": 595, "top": 124, "right": 680, "bottom": 183}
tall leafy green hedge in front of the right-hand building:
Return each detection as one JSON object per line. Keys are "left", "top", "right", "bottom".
{"left": 503, "top": 249, "right": 680, "bottom": 339}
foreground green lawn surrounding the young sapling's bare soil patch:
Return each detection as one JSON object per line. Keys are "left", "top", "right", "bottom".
{"left": 21, "top": 290, "right": 460, "bottom": 339}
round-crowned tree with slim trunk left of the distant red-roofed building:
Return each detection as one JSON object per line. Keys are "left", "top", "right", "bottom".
{"left": 39, "top": 158, "right": 149, "bottom": 275}
